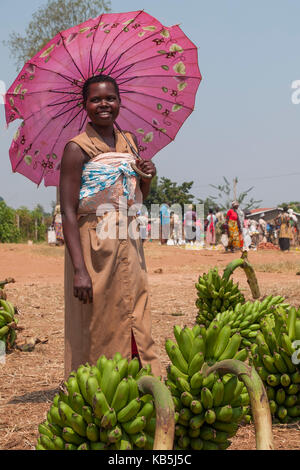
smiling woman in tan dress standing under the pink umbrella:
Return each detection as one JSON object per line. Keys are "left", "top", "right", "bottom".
{"left": 60, "top": 75, "right": 161, "bottom": 377}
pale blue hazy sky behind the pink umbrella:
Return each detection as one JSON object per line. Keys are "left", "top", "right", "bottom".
{"left": 0, "top": 0, "right": 300, "bottom": 211}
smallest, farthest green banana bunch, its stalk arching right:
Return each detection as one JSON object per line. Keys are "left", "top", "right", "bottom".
{"left": 195, "top": 268, "right": 245, "bottom": 327}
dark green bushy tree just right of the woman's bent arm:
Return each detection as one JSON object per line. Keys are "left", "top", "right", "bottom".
{"left": 144, "top": 176, "right": 194, "bottom": 210}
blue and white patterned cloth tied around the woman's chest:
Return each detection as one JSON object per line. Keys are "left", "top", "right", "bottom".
{"left": 79, "top": 162, "right": 137, "bottom": 200}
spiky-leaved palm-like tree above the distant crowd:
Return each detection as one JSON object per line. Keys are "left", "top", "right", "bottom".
{"left": 209, "top": 176, "right": 262, "bottom": 211}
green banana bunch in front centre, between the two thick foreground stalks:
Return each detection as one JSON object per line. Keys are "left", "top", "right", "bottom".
{"left": 165, "top": 320, "right": 249, "bottom": 450}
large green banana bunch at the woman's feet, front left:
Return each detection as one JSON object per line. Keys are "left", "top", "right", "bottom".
{"left": 36, "top": 353, "right": 156, "bottom": 450}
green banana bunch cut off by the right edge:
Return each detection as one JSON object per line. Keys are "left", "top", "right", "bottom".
{"left": 251, "top": 306, "right": 300, "bottom": 423}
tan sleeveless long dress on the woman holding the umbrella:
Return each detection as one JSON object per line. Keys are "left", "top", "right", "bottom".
{"left": 65, "top": 124, "right": 161, "bottom": 378}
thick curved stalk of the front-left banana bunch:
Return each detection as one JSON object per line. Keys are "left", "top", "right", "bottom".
{"left": 137, "top": 376, "right": 175, "bottom": 450}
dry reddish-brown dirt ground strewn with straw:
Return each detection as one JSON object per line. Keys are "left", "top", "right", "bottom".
{"left": 0, "top": 242, "right": 300, "bottom": 450}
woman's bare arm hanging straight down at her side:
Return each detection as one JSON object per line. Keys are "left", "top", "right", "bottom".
{"left": 60, "top": 142, "right": 92, "bottom": 303}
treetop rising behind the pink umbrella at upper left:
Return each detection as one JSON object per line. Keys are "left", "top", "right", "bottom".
{"left": 4, "top": 0, "right": 111, "bottom": 68}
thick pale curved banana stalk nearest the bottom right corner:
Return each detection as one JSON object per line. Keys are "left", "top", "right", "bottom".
{"left": 201, "top": 359, "right": 274, "bottom": 450}
